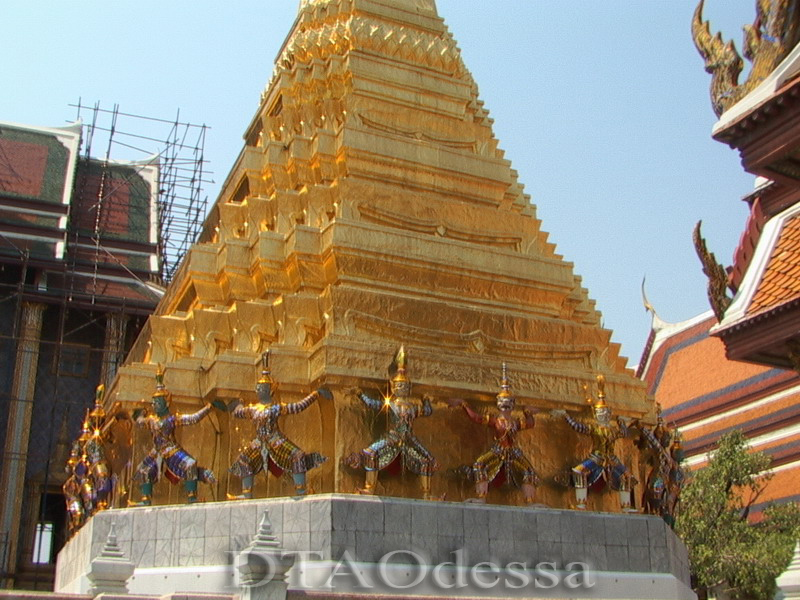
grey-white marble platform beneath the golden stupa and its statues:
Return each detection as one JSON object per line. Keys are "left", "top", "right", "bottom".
{"left": 56, "top": 494, "right": 694, "bottom": 600}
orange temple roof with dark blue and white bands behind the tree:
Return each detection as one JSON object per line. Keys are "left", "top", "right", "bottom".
{"left": 640, "top": 311, "right": 800, "bottom": 482}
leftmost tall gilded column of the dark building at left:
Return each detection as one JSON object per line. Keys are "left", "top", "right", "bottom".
{"left": 0, "top": 302, "right": 45, "bottom": 587}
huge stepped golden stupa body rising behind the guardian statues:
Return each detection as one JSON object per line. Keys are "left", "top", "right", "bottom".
{"left": 109, "top": 0, "right": 654, "bottom": 510}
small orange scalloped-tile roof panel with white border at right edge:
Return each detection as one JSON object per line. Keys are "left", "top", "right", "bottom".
{"left": 747, "top": 216, "right": 800, "bottom": 315}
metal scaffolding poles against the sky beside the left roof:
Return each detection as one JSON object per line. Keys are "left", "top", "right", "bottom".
{"left": 70, "top": 99, "right": 214, "bottom": 284}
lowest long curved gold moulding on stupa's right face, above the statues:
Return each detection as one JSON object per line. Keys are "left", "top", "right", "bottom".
{"left": 345, "top": 310, "right": 594, "bottom": 369}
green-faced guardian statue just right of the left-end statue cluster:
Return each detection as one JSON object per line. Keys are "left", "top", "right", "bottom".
{"left": 133, "top": 366, "right": 216, "bottom": 506}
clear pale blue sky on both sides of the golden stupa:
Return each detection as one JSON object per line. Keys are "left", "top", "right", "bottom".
{"left": 0, "top": 0, "right": 755, "bottom": 365}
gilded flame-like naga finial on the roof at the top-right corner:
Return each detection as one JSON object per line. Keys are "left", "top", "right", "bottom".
{"left": 692, "top": 0, "right": 800, "bottom": 117}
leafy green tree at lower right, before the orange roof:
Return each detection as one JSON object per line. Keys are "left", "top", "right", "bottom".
{"left": 676, "top": 430, "right": 800, "bottom": 599}
